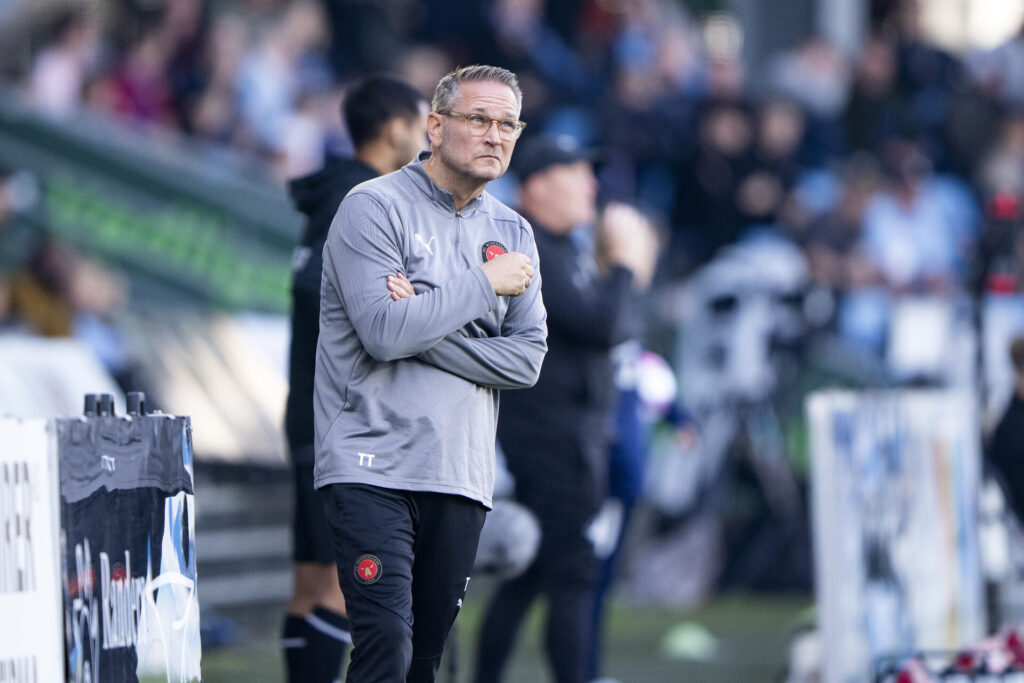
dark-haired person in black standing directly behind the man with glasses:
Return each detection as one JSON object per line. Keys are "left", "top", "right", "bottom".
{"left": 282, "top": 77, "right": 428, "bottom": 683}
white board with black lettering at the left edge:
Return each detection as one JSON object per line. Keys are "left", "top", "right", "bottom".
{"left": 0, "top": 418, "right": 63, "bottom": 683}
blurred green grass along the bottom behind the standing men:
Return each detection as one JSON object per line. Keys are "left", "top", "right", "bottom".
{"left": 197, "top": 580, "right": 812, "bottom": 683}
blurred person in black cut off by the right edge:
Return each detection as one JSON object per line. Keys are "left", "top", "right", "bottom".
{"left": 988, "top": 335, "right": 1024, "bottom": 520}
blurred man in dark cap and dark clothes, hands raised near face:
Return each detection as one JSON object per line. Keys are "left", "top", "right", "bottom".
{"left": 475, "top": 135, "right": 654, "bottom": 683}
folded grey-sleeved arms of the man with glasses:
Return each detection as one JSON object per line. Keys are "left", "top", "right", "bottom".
{"left": 324, "top": 193, "right": 547, "bottom": 389}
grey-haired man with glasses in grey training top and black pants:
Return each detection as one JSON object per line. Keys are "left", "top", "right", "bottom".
{"left": 314, "top": 66, "right": 547, "bottom": 683}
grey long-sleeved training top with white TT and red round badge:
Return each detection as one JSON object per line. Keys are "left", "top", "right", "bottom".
{"left": 313, "top": 153, "right": 548, "bottom": 508}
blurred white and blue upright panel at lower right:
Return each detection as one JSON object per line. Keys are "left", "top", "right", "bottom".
{"left": 807, "top": 391, "right": 985, "bottom": 683}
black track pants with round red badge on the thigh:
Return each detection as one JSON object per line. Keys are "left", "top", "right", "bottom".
{"left": 321, "top": 484, "right": 485, "bottom": 683}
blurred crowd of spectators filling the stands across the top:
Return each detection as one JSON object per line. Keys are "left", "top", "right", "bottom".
{"left": 4, "top": 0, "right": 1024, "bottom": 344}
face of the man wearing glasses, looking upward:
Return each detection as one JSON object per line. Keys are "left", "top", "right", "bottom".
{"left": 427, "top": 81, "right": 525, "bottom": 185}
